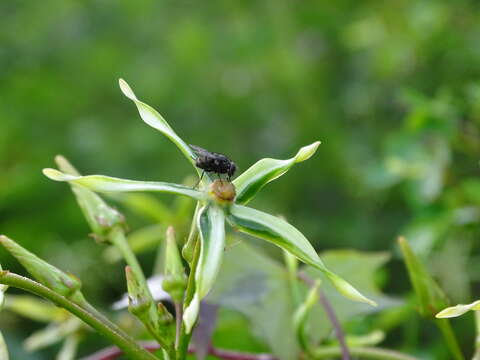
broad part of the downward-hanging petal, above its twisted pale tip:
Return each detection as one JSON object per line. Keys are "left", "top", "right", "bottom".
{"left": 195, "top": 205, "right": 225, "bottom": 300}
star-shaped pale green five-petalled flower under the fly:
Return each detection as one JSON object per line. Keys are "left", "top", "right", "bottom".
{"left": 43, "top": 79, "right": 375, "bottom": 332}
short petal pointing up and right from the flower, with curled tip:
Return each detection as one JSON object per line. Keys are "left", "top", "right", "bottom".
{"left": 233, "top": 141, "right": 320, "bottom": 204}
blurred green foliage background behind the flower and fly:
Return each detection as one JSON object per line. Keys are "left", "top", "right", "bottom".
{"left": 0, "top": 0, "right": 480, "bottom": 359}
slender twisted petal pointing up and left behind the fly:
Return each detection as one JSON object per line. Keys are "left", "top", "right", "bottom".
{"left": 118, "top": 79, "right": 198, "bottom": 171}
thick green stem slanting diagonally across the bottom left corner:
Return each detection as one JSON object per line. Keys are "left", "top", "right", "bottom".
{"left": 0, "top": 271, "right": 157, "bottom": 360}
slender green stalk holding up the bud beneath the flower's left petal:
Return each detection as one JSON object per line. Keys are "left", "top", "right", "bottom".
{"left": 109, "top": 227, "right": 175, "bottom": 359}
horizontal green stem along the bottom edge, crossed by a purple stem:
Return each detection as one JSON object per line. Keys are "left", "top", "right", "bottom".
{"left": 312, "top": 347, "right": 418, "bottom": 360}
